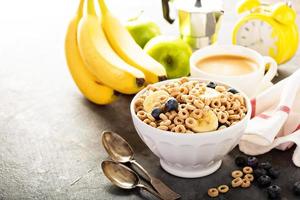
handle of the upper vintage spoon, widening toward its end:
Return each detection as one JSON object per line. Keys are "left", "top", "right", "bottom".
{"left": 130, "top": 160, "right": 181, "bottom": 200}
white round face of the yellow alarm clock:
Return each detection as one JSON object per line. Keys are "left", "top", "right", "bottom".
{"left": 236, "top": 19, "right": 278, "bottom": 56}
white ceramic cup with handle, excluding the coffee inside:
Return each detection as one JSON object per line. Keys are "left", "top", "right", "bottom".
{"left": 190, "top": 45, "right": 277, "bottom": 97}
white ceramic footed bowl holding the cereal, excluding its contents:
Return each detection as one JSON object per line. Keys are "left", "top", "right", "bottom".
{"left": 130, "top": 78, "right": 251, "bottom": 178}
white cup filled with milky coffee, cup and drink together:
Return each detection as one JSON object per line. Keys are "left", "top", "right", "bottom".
{"left": 190, "top": 44, "right": 277, "bottom": 97}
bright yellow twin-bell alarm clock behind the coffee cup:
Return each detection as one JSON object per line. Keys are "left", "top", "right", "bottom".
{"left": 232, "top": 0, "right": 298, "bottom": 64}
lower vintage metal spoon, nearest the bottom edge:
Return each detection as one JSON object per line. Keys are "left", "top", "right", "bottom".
{"left": 101, "top": 161, "right": 164, "bottom": 200}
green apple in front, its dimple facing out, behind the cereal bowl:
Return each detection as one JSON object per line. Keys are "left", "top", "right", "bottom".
{"left": 144, "top": 35, "right": 192, "bottom": 79}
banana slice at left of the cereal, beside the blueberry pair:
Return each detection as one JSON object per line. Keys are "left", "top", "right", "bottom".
{"left": 143, "top": 90, "right": 169, "bottom": 113}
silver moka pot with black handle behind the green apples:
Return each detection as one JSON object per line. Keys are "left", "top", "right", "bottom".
{"left": 162, "top": 0, "right": 223, "bottom": 49}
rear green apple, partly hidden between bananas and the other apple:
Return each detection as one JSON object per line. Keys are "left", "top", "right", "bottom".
{"left": 126, "top": 19, "right": 160, "bottom": 48}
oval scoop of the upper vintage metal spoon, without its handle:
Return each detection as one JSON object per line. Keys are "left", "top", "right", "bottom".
{"left": 102, "top": 131, "right": 134, "bottom": 163}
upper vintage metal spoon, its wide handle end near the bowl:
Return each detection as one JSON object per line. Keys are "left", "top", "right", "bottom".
{"left": 102, "top": 131, "right": 181, "bottom": 200}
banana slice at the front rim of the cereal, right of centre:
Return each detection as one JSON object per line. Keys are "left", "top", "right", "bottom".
{"left": 192, "top": 110, "right": 219, "bottom": 133}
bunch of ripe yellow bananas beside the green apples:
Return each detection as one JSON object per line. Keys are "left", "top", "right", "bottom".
{"left": 65, "top": 0, "right": 166, "bottom": 104}
